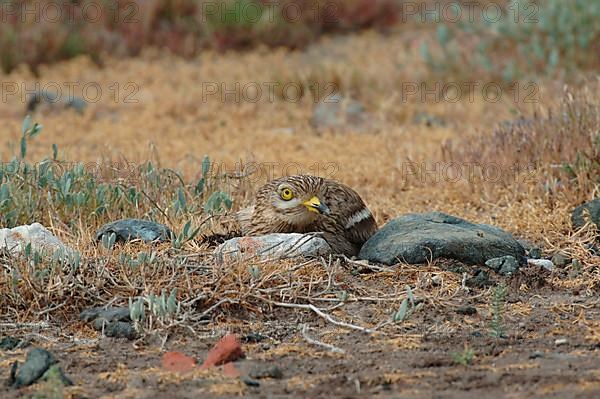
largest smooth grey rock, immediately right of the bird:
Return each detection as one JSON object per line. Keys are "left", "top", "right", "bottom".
{"left": 358, "top": 212, "right": 525, "bottom": 265}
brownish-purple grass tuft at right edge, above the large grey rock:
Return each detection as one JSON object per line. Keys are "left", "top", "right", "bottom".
{"left": 442, "top": 83, "right": 600, "bottom": 203}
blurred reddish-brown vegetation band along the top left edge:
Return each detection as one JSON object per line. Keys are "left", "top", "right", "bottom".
{"left": 0, "top": 0, "right": 401, "bottom": 71}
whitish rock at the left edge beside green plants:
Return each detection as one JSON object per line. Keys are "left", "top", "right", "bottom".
{"left": 0, "top": 223, "right": 69, "bottom": 255}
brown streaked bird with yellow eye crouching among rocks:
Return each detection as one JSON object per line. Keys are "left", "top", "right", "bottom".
{"left": 237, "top": 175, "right": 377, "bottom": 256}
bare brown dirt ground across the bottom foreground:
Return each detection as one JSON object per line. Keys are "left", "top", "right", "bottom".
{"left": 0, "top": 260, "right": 600, "bottom": 398}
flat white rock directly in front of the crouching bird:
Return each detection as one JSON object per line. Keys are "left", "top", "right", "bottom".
{"left": 215, "top": 233, "right": 331, "bottom": 263}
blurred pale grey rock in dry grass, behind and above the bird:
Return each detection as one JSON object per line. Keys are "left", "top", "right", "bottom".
{"left": 310, "top": 94, "right": 369, "bottom": 131}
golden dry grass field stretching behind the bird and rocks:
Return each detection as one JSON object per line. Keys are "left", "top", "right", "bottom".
{"left": 2, "top": 31, "right": 598, "bottom": 319}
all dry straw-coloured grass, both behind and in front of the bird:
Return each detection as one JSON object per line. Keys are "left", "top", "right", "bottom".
{"left": 0, "top": 22, "right": 600, "bottom": 399}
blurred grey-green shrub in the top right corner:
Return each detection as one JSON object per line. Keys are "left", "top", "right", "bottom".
{"left": 421, "top": 0, "right": 600, "bottom": 84}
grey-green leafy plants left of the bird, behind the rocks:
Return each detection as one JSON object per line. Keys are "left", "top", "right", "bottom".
{"left": 0, "top": 116, "right": 233, "bottom": 233}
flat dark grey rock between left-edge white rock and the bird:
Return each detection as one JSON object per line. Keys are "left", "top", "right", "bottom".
{"left": 96, "top": 219, "right": 173, "bottom": 242}
